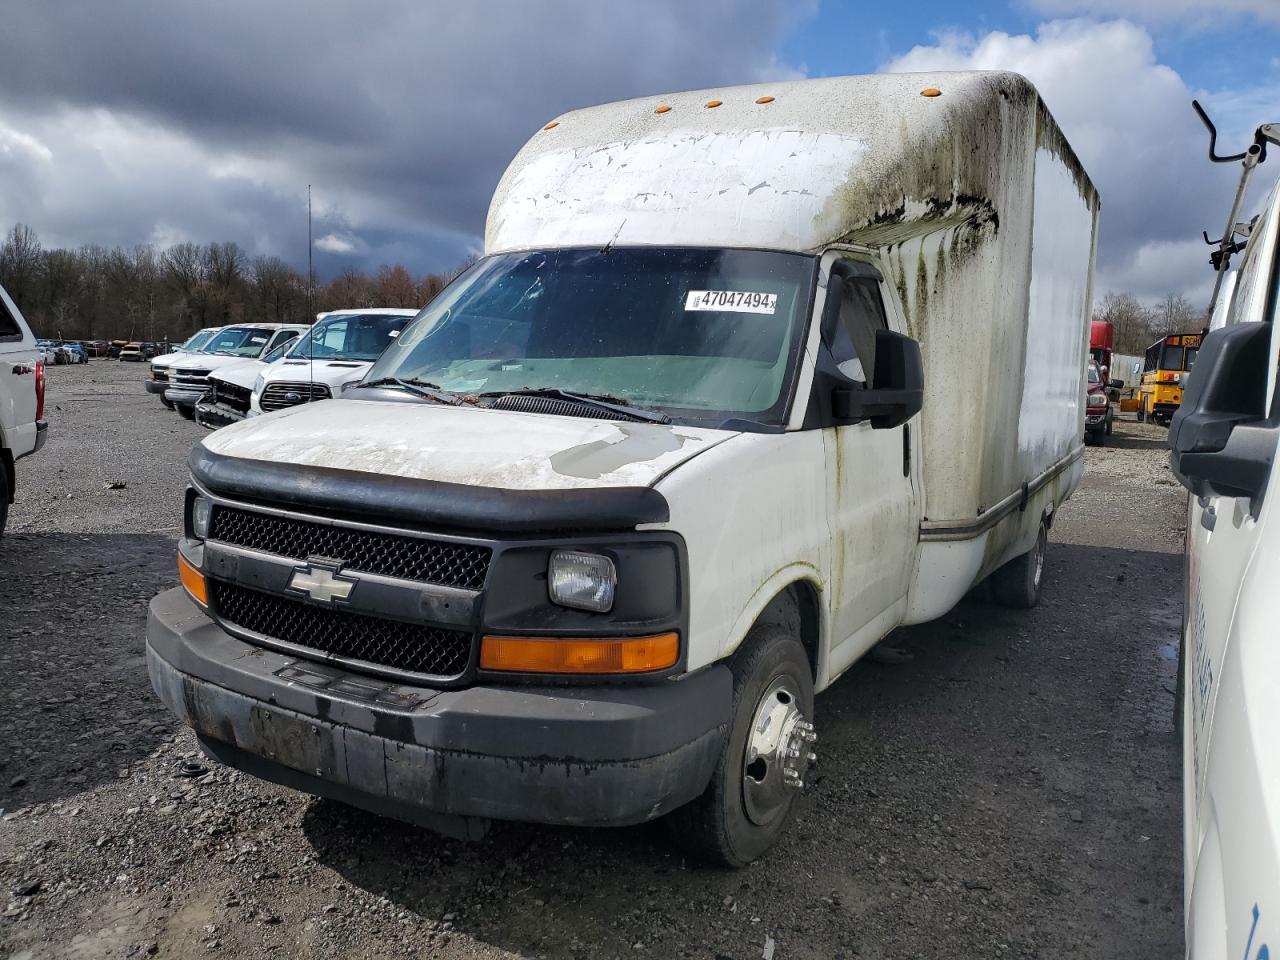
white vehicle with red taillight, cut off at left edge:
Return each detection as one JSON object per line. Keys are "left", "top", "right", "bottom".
{"left": 0, "top": 287, "right": 49, "bottom": 536}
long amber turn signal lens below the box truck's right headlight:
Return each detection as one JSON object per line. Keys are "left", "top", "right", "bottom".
{"left": 480, "top": 634, "right": 680, "bottom": 673}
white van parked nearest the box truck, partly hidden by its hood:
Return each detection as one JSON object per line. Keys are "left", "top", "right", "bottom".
{"left": 248, "top": 307, "right": 417, "bottom": 416}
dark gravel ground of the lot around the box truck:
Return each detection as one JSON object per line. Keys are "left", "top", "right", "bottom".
{"left": 0, "top": 361, "right": 1185, "bottom": 960}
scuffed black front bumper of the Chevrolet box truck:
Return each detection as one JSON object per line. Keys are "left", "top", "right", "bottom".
{"left": 147, "top": 589, "right": 732, "bottom": 832}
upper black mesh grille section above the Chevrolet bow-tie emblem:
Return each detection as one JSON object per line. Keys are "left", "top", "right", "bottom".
{"left": 209, "top": 504, "right": 493, "bottom": 590}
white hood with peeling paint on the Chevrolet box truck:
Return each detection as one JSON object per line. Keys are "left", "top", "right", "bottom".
{"left": 202, "top": 399, "right": 735, "bottom": 490}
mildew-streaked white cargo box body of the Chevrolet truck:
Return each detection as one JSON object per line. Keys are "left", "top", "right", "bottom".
{"left": 485, "top": 72, "right": 1100, "bottom": 576}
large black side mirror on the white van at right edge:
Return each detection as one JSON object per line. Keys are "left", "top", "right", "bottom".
{"left": 1169, "top": 323, "right": 1280, "bottom": 499}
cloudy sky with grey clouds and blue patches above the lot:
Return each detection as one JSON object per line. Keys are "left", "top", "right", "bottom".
{"left": 0, "top": 0, "right": 1280, "bottom": 308}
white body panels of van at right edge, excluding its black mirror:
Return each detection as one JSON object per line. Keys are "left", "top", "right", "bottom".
{"left": 1174, "top": 175, "right": 1280, "bottom": 960}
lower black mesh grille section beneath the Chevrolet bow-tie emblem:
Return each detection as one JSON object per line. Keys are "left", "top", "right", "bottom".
{"left": 210, "top": 580, "right": 472, "bottom": 680}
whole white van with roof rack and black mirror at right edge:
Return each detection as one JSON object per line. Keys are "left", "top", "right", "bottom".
{"left": 1172, "top": 127, "right": 1280, "bottom": 960}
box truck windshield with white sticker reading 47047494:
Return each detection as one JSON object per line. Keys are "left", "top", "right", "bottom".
{"left": 366, "top": 247, "right": 817, "bottom": 422}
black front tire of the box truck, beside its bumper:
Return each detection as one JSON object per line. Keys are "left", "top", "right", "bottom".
{"left": 667, "top": 626, "right": 813, "bottom": 867}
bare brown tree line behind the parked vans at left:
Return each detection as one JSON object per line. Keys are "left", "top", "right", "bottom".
{"left": 0, "top": 224, "right": 461, "bottom": 342}
